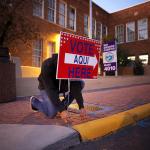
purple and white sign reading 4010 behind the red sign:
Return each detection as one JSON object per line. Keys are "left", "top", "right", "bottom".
{"left": 102, "top": 41, "right": 117, "bottom": 72}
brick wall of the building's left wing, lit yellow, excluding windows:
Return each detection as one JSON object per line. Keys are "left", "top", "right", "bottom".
{"left": 11, "top": 0, "right": 89, "bottom": 66}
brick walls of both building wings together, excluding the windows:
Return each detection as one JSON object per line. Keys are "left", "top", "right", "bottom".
{"left": 11, "top": 0, "right": 150, "bottom": 66}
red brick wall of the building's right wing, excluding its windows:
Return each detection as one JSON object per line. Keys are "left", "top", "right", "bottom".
{"left": 108, "top": 2, "right": 150, "bottom": 64}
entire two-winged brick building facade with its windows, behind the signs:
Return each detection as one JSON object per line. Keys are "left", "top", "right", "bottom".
{"left": 11, "top": 0, "right": 150, "bottom": 67}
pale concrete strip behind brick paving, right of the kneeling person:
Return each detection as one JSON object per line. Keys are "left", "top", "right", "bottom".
{"left": 84, "top": 76, "right": 150, "bottom": 92}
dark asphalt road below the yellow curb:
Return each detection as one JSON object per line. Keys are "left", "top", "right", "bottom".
{"left": 68, "top": 118, "right": 150, "bottom": 150}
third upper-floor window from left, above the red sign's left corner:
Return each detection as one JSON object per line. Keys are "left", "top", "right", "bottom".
{"left": 59, "top": 2, "right": 66, "bottom": 27}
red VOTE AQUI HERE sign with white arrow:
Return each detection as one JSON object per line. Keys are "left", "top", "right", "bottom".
{"left": 57, "top": 32, "right": 101, "bottom": 79}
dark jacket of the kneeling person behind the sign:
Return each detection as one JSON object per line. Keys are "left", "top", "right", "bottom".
{"left": 38, "top": 54, "right": 84, "bottom": 112}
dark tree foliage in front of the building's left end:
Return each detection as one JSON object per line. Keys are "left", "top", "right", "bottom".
{"left": 0, "top": 0, "right": 39, "bottom": 49}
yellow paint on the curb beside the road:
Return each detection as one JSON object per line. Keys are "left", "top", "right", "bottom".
{"left": 73, "top": 103, "right": 150, "bottom": 141}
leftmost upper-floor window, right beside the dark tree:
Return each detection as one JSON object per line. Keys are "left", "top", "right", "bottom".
{"left": 33, "top": 0, "right": 44, "bottom": 18}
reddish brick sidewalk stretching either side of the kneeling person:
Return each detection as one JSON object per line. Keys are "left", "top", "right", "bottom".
{"left": 0, "top": 76, "right": 150, "bottom": 126}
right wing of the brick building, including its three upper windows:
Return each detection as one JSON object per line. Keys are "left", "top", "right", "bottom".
{"left": 108, "top": 2, "right": 150, "bottom": 65}
